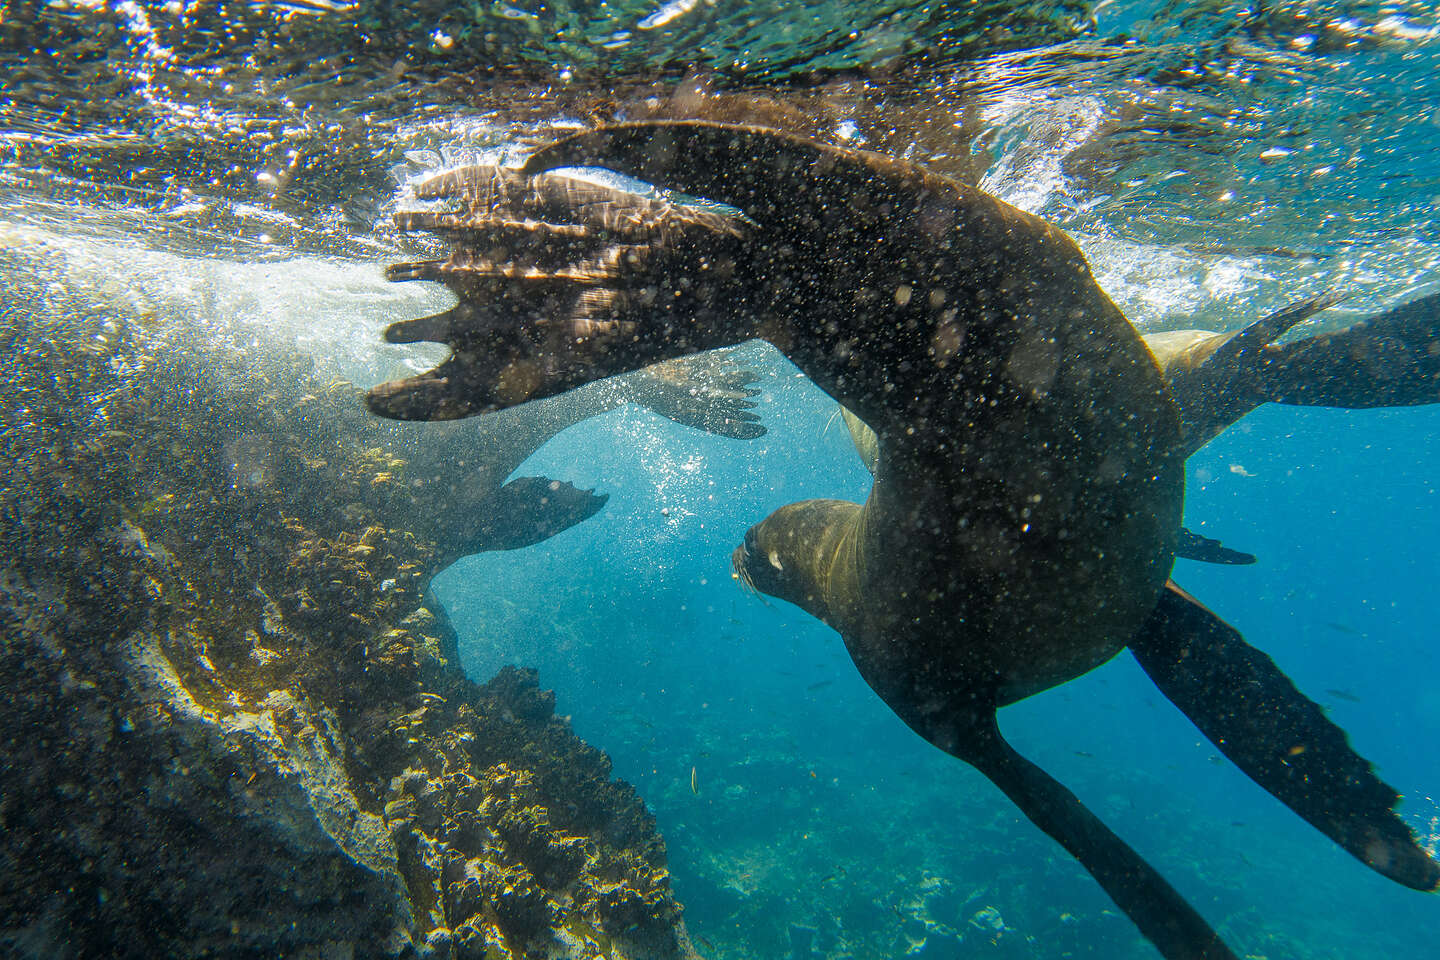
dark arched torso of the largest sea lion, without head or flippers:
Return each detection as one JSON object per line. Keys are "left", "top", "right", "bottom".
{"left": 527, "top": 124, "right": 1184, "bottom": 719}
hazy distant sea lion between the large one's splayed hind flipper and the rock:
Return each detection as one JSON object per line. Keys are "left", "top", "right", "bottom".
{"left": 413, "top": 351, "right": 765, "bottom": 554}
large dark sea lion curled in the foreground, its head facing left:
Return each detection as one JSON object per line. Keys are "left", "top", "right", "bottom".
{"left": 362, "top": 121, "right": 1440, "bottom": 960}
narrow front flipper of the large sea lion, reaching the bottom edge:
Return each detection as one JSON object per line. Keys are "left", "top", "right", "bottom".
{"left": 950, "top": 712, "right": 1236, "bottom": 960}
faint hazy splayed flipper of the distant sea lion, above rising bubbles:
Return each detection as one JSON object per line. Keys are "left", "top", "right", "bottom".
{"left": 628, "top": 351, "right": 765, "bottom": 440}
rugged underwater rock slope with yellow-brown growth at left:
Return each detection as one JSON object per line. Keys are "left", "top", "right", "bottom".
{"left": 0, "top": 230, "right": 694, "bottom": 960}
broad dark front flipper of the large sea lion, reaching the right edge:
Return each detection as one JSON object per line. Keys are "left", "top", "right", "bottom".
{"left": 1130, "top": 583, "right": 1440, "bottom": 889}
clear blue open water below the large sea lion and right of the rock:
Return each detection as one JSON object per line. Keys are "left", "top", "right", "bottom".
{"left": 436, "top": 347, "right": 1440, "bottom": 959}
